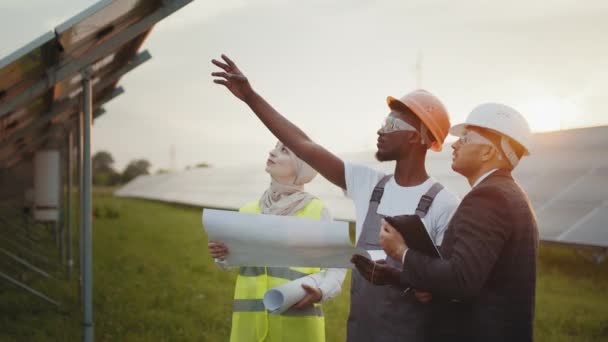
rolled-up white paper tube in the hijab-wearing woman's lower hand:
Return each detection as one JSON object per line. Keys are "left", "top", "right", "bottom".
{"left": 263, "top": 276, "right": 317, "bottom": 314}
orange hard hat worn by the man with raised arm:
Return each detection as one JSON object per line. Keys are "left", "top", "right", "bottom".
{"left": 386, "top": 89, "right": 450, "bottom": 152}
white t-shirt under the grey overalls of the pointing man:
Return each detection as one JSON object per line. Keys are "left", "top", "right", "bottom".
{"left": 344, "top": 162, "right": 460, "bottom": 246}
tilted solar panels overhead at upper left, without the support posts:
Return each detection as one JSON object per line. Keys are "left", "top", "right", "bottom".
{"left": 0, "top": 0, "right": 191, "bottom": 168}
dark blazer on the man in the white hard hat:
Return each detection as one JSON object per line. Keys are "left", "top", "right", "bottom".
{"left": 401, "top": 170, "right": 538, "bottom": 341}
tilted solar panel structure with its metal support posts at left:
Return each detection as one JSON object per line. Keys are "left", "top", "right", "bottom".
{"left": 0, "top": 0, "right": 192, "bottom": 341}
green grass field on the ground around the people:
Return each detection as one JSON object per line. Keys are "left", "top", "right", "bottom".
{"left": 0, "top": 193, "right": 608, "bottom": 342}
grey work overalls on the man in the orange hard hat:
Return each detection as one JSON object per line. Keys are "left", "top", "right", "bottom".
{"left": 347, "top": 175, "right": 443, "bottom": 342}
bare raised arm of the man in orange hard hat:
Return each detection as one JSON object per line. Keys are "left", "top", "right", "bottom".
{"left": 211, "top": 55, "right": 346, "bottom": 189}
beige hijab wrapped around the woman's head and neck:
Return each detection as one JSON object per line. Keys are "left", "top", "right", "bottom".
{"left": 260, "top": 145, "right": 317, "bottom": 216}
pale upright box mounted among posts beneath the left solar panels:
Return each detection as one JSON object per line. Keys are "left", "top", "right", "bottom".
{"left": 34, "top": 151, "right": 61, "bottom": 221}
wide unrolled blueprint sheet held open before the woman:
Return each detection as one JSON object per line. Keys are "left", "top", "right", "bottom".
{"left": 203, "top": 209, "right": 369, "bottom": 268}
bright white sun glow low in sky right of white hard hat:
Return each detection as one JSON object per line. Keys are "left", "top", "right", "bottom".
{"left": 517, "top": 97, "right": 582, "bottom": 132}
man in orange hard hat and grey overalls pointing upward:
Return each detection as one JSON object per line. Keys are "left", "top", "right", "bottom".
{"left": 212, "top": 55, "right": 459, "bottom": 342}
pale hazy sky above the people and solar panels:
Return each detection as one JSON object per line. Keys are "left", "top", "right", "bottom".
{"left": 0, "top": 0, "right": 608, "bottom": 171}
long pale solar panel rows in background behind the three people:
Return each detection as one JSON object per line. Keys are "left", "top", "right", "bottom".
{"left": 116, "top": 127, "right": 608, "bottom": 247}
